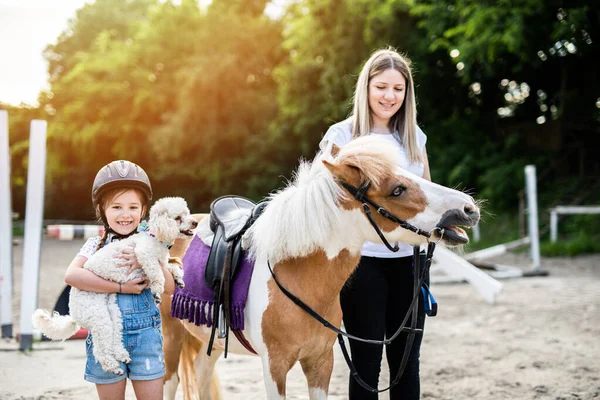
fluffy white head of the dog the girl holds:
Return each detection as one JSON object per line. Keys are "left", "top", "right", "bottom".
{"left": 148, "top": 197, "right": 198, "bottom": 243}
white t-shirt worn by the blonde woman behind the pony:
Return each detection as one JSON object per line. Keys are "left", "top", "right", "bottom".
{"left": 319, "top": 119, "right": 427, "bottom": 258}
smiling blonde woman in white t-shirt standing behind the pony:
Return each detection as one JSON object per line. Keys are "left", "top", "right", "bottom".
{"left": 320, "top": 49, "right": 431, "bottom": 400}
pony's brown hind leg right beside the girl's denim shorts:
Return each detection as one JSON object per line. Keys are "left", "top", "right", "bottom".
{"left": 158, "top": 294, "right": 183, "bottom": 400}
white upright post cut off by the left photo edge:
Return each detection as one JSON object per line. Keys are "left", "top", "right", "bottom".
{"left": 0, "top": 110, "right": 13, "bottom": 338}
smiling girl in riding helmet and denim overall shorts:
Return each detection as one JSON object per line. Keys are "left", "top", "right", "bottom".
{"left": 65, "top": 160, "right": 175, "bottom": 400}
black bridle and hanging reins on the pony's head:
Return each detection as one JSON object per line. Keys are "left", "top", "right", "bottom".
{"left": 267, "top": 180, "right": 444, "bottom": 393}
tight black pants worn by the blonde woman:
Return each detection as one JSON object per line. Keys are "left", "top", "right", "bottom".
{"left": 340, "top": 255, "right": 425, "bottom": 400}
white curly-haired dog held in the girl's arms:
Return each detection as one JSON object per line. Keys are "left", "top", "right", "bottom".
{"left": 32, "top": 197, "right": 198, "bottom": 375}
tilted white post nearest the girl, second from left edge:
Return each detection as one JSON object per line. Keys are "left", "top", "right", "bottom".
{"left": 19, "top": 120, "right": 48, "bottom": 350}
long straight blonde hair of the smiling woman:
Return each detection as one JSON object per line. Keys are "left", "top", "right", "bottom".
{"left": 350, "top": 48, "right": 424, "bottom": 163}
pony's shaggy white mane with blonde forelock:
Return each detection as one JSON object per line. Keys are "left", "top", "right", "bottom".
{"left": 245, "top": 137, "right": 398, "bottom": 265}
